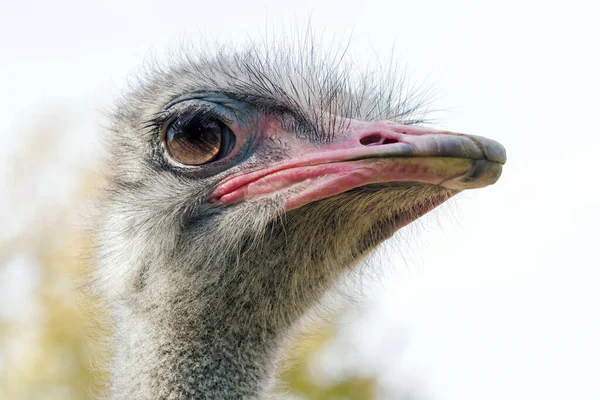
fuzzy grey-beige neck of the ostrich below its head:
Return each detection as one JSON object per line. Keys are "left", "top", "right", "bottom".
{"left": 106, "top": 217, "right": 346, "bottom": 400}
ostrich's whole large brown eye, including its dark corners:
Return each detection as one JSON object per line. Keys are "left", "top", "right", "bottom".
{"left": 164, "top": 113, "right": 235, "bottom": 165}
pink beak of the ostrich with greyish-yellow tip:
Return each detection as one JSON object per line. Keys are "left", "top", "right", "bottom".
{"left": 211, "top": 120, "right": 506, "bottom": 211}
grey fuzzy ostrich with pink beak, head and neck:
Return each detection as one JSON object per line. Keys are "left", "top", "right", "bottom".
{"left": 94, "top": 39, "right": 506, "bottom": 399}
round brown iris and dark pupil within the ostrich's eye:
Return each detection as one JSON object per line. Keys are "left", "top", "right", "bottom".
{"left": 167, "top": 119, "right": 223, "bottom": 165}
